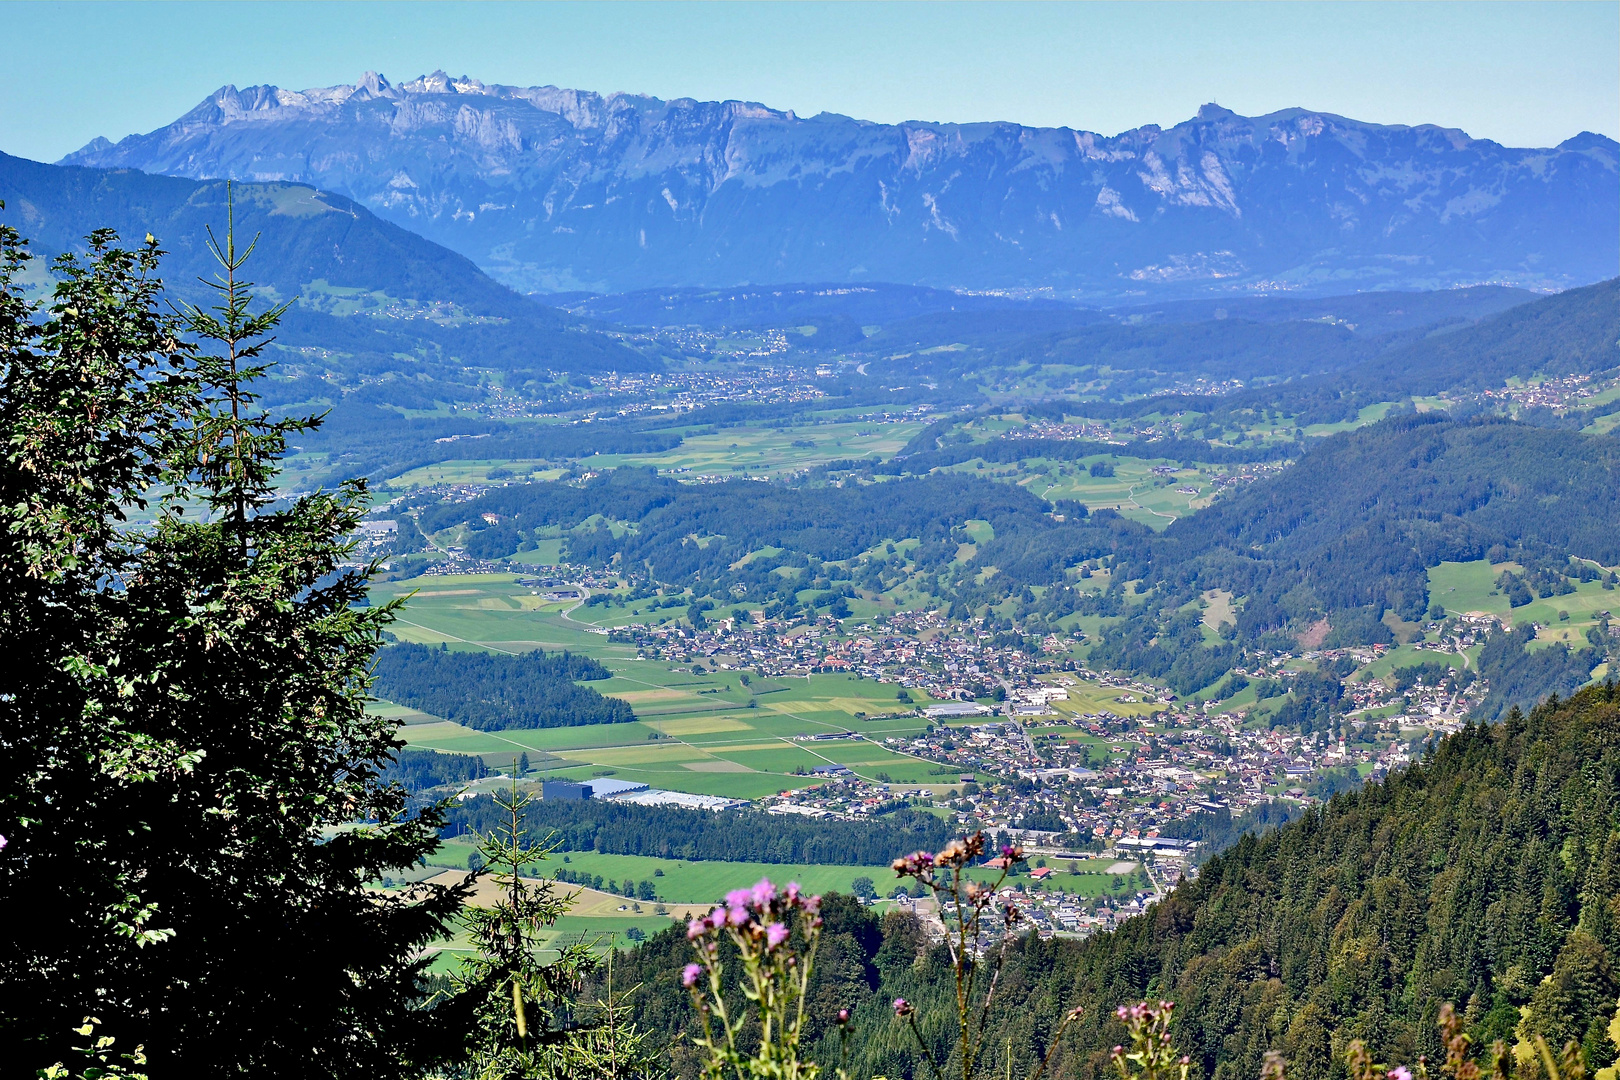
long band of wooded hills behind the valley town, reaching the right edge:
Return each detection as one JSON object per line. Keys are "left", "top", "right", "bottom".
{"left": 421, "top": 415, "right": 1620, "bottom": 696}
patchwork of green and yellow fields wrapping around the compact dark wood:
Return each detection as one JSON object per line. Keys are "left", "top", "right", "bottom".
{"left": 374, "top": 575, "right": 956, "bottom": 798}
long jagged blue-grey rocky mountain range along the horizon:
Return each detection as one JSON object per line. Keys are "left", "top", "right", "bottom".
{"left": 65, "top": 73, "right": 1620, "bottom": 298}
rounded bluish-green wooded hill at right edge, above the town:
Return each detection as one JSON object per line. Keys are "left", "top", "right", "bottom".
{"left": 1126, "top": 416, "right": 1620, "bottom": 630}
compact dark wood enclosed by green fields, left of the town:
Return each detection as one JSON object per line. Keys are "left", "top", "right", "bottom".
{"left": 373, "top": 644, "right": 635, "bottom": 732}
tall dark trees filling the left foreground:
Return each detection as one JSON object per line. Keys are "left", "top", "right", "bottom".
{"left": 0, "top": 196, "right": 465, "bottom": 1077}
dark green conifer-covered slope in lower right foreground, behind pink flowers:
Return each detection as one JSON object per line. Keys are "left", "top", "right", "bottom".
{"left": 614, "top": 683, "right": 1620, "bottom": 1080}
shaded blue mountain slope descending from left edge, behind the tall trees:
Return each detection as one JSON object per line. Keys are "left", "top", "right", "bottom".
{"left": 0, "top": 154, "right": 646, "bottom": 369}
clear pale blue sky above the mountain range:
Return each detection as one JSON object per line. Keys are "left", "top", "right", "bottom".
{"left": 0, "top": 0, "right": 1620, "bottom": 160}
